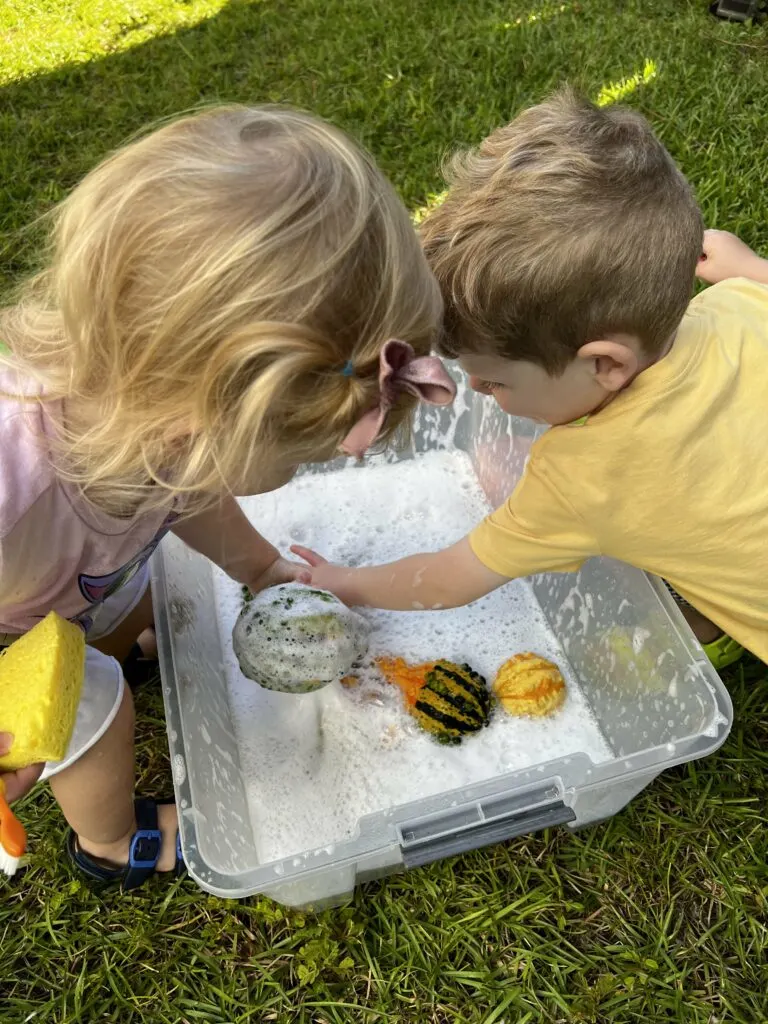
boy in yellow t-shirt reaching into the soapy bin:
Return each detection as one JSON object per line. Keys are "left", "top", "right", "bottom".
{"left": 298, "top": 90, "right": 768, "bottom": 665}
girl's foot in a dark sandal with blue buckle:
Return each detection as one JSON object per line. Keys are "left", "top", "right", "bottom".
{"left": 69, "top": 800, "right": 183, "bottom": 889}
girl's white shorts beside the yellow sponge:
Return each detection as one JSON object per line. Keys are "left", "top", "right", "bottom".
{"left": 41, "top": 565, "right": 150, "bottom": 778}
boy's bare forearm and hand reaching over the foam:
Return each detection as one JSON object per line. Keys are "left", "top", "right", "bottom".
{"left": 291, "top": 537, "right": 509, "bottom": 611}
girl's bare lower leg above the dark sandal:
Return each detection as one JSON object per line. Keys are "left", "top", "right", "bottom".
{"left": 50, "top": 686, "right": 177, "bottom": 871}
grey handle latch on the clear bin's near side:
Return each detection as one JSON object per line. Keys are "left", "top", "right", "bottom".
{"left": 400, "top": 800, "right": 575, "bottom": 868}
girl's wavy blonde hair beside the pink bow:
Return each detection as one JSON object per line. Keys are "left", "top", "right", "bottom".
{"left": 0, "top": 106, "right": 441, "bottom": 515}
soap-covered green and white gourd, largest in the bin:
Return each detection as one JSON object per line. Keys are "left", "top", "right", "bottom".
{"left": 232, "top": 584, "right": 371, "bottom": 693}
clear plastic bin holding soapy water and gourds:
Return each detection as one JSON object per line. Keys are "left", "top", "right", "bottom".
{"left": 153, "top": 380, "right": 732, "bottom": 907}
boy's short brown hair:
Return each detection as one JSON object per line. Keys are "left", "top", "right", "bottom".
{"left": 422, "top": 88, "right": 703, "bottom": 375}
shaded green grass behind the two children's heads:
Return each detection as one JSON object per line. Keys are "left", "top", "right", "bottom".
{"left": 0, "top": 0, "right": 768, "bottom": 289}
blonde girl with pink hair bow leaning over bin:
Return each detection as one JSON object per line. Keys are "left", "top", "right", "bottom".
{"left": 0, "top": 108, "right": 453, "bottom": 888}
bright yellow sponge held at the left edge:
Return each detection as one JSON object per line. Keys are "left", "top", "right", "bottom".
{"left": 0, "top": 611, "right": 85, "bottom": 771}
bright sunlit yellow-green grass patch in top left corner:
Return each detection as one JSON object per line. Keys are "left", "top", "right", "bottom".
{"left": 0, "top": 0, "right": 228, "bottom": 85}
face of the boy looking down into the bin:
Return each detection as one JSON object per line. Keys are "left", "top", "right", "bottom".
{"left": 459, "top": 354, "right": 606, "bottom": 426}
